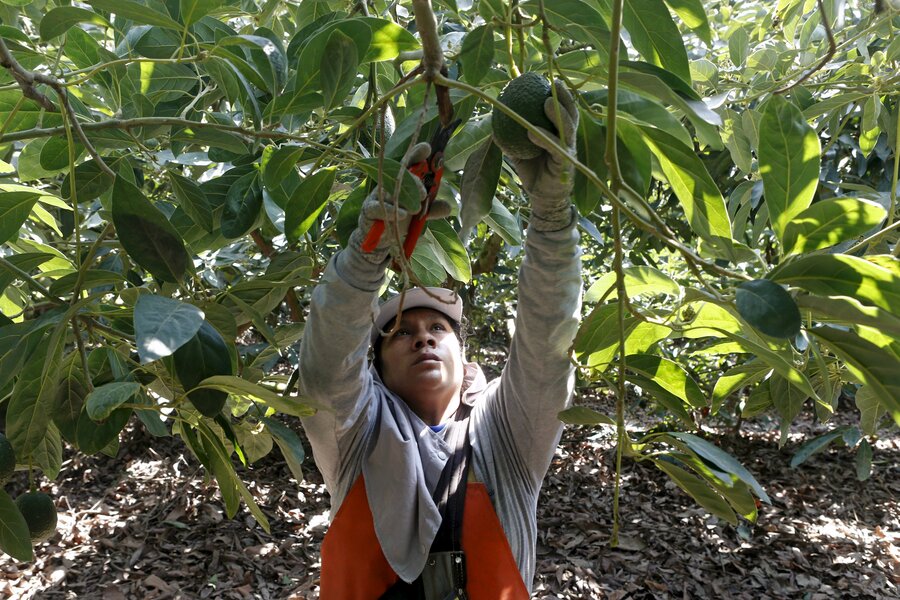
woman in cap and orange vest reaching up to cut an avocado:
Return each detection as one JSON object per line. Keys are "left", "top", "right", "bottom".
{"left": 300, "top": 83, "right": 581, "bottom": 600}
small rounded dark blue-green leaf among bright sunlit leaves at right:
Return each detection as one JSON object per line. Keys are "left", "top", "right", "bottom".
{"left": 735, "top": 279, "right": 801, "bottom": 338}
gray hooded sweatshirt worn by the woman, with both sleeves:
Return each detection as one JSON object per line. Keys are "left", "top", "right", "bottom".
{"left": 300, "top": 218, "right": 581, "bottom": 591}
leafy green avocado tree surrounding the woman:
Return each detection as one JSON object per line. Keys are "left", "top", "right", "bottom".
{"left": 0, "top": 0, "right": 900, "bottom": 560}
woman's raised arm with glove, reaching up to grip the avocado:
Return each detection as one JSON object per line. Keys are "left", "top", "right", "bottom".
{"left": 491, "top": 82, "right": 581, "bottom": 484}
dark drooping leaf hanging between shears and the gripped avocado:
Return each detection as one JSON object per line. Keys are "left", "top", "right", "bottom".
{"left": 459, "top": 138, "right": 503, "bottom": 241}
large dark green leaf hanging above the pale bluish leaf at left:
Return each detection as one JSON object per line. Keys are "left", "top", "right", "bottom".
{"left": 112, "top": 177, "right": 190, "bottom": 283}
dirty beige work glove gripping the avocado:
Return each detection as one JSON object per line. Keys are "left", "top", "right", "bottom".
{"left": 498, "top": 80, "right": 578, "bottom": 231}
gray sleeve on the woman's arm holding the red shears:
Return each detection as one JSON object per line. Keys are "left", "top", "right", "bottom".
{"left": 300, "top": 250, "right": 385, "bottom": 494}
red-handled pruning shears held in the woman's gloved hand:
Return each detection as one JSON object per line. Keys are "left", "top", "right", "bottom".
{"left": 360, "top": 89, "right": 462, "bottom": 258}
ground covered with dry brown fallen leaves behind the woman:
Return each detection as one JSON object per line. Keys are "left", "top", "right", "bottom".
{"left": 0, "top": 394, "right": 900, "bottom": 600}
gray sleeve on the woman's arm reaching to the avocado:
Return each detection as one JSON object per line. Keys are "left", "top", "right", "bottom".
{"left": 485, "top": 213, "right": 581, "bottom": 487}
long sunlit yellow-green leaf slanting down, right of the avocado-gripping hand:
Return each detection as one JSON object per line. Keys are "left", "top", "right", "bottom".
{"left": 641, "top": 128, "right": 731, "bottom": 252}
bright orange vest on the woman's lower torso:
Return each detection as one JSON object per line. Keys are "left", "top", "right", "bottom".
{"left": 320, "top": 475, "right": 528, "bottom": 600}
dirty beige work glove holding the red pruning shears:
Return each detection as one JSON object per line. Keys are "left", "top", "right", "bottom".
{"left": 347, "top": 142, "right": 450, "bottom": 265}
